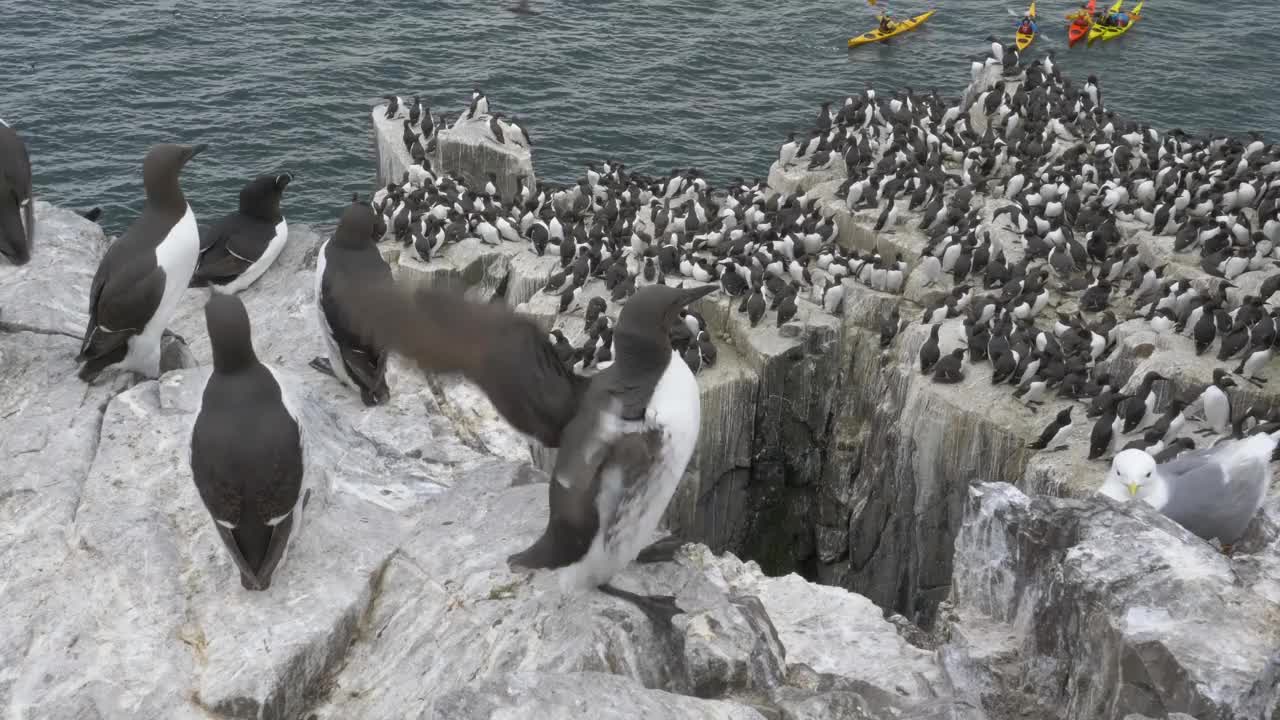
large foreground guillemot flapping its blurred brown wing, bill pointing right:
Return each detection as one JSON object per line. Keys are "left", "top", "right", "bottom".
{"left": 325, "top": 275, "right": 719, "bottom": 623}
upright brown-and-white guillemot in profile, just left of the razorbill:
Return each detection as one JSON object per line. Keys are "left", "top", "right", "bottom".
{"left": 76, "top": 143, "right": 205, "bottom": 382}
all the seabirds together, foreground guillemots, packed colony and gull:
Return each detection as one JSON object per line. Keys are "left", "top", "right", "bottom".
{"left": 0, "top": 37, "right": 1280, "bottom": 623}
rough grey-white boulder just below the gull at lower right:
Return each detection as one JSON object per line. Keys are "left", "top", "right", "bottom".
{"left": 943, "top": 483, "right": 1280, "bottom": 720}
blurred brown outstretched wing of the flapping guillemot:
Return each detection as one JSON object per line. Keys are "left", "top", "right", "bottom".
{"left": 332, "top": 273, "right": 589, "bottom": 447}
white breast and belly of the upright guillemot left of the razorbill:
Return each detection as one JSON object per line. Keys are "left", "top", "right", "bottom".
{"left": 119, "top": 205, "right": 200, "bottom": 378}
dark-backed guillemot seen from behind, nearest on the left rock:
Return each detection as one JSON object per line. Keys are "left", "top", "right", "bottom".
{"left": 191, "top": 293, "right": 311, "bottom": 591}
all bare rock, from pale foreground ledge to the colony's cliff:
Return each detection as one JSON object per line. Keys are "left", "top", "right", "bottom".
{"left": 0, "top": 65, "right": 1280, "bottom": 720}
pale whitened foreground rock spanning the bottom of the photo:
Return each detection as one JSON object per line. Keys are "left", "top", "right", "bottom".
{"left": 0, "top": 189, "right": 1280, "bottom": 720}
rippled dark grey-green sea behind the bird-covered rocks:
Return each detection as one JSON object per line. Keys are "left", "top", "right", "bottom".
{"left": 0, "top": 0, "right": 1280, "bottom": 232}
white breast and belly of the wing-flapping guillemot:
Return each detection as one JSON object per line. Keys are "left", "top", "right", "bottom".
{"left": 561, "top": 351, "right": 701, "bottom": 589}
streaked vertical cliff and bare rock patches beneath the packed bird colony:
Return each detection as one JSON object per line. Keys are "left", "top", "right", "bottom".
{"left": 372, "top": 101, "right": 1280, "bottom": 625}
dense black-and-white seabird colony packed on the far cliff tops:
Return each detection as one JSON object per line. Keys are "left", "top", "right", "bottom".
{"left": 372, "top": 42, "right": 1280, "bottom": 545}
